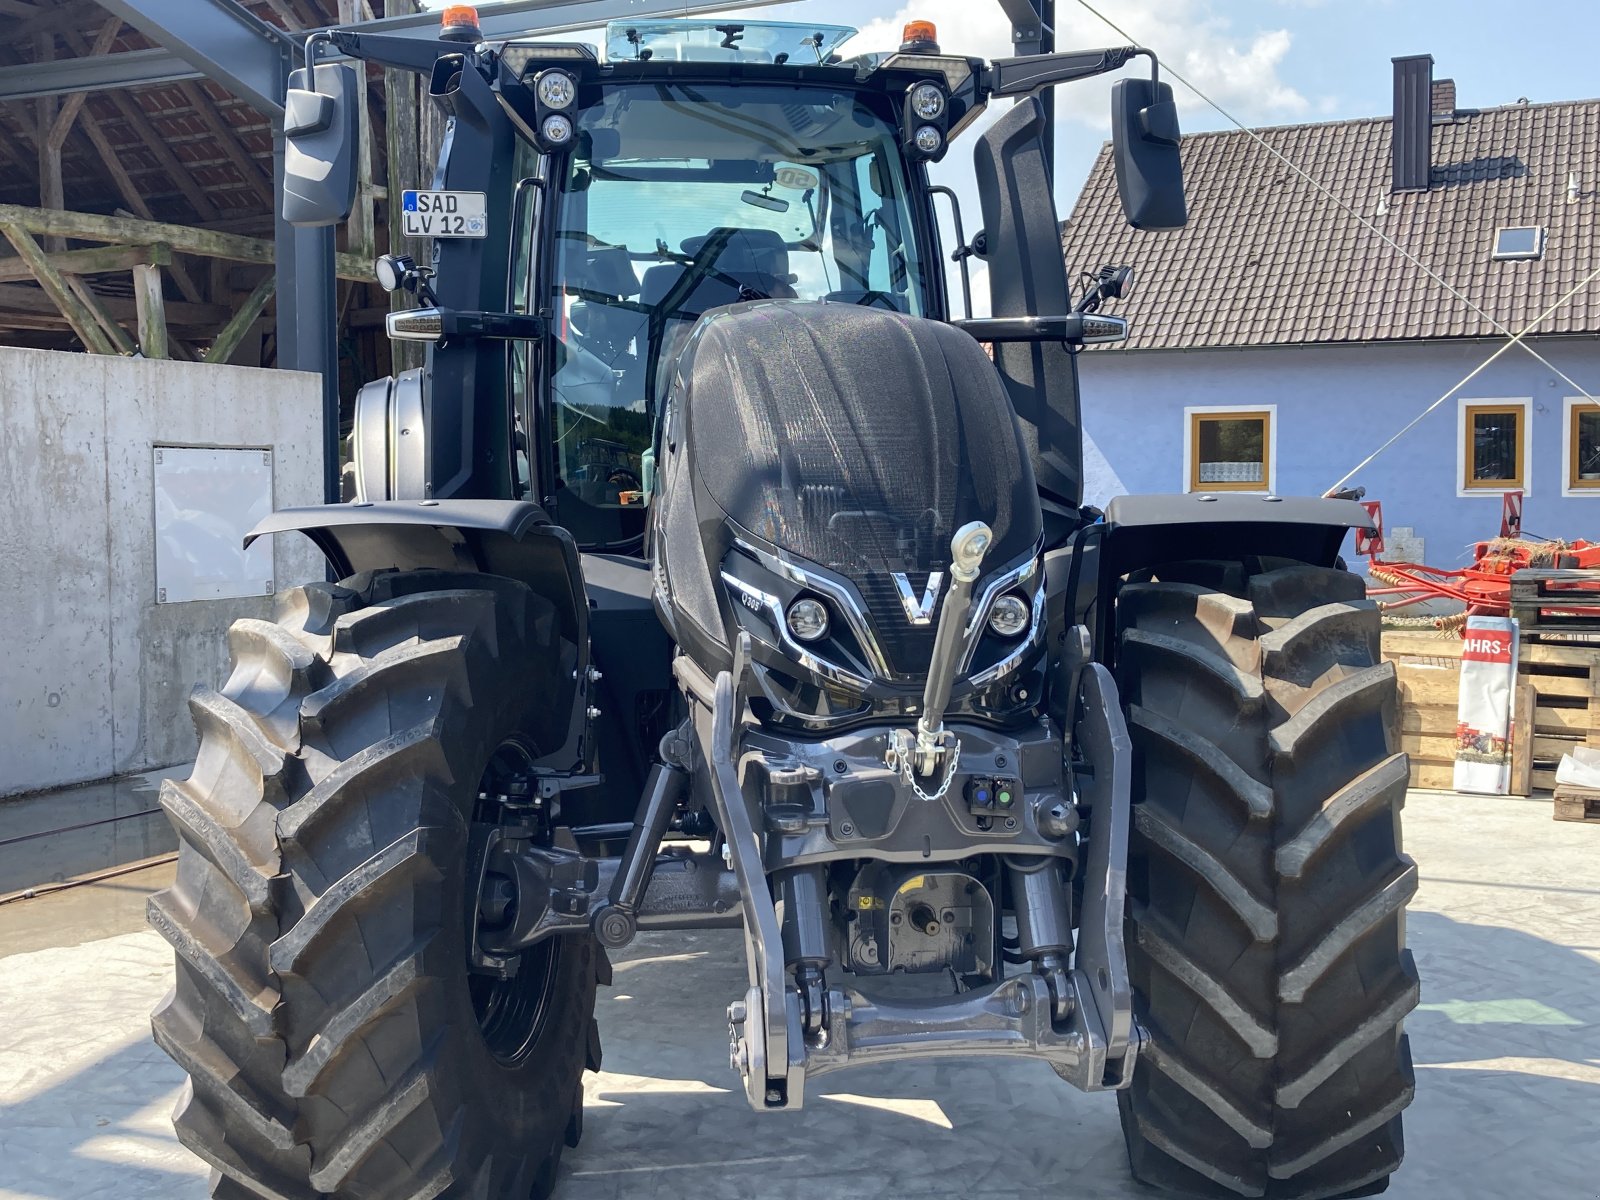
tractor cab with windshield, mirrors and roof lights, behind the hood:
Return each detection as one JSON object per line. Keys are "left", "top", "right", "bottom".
{"left": 312, "top": 19, "right": 1182, "bottom": 555}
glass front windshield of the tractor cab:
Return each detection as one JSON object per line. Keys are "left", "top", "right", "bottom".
{"left": 546, "top": 83, "right": 928, "bottom": 546}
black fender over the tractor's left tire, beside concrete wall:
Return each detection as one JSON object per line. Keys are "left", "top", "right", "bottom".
{"left": 245, "top": 499, "right": 590, "bottom": 765}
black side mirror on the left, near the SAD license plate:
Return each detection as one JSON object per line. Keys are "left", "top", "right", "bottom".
{"left": 283, "top": 62, "right": 363, "bottom": 227}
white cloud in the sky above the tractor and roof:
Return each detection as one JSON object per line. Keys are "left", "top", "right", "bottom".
{"left": 850, "top": 0, "right": 1310, "bottom": 131}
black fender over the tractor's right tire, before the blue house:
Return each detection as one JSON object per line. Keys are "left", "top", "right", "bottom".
{"left": 1045, "top": 493, "right": 1373, "bottom": 662}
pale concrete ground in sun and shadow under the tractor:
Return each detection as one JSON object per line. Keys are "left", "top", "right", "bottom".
{"left": 0, "top": 792, "right": 1600, "bottom": 1200}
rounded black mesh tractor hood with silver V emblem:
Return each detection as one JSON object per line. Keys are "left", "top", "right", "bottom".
{"left": 672, "top": 301, "right": 1040, "bottom": 678}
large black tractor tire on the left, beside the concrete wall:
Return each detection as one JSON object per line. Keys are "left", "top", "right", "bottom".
{"left": 150, "top": 571, "right": 603, "bottom": 1200}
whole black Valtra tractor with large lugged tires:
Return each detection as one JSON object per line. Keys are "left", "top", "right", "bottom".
{"left": 150, "top": 11, "right": 1418, "bottom": 1200}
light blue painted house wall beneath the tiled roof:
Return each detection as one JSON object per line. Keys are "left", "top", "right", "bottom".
{"left": 1078, "top": 339, "right": 1600, "bottom": 566}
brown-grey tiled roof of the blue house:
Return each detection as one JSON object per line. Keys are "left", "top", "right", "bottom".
{"left": 1062, "top": 99, "right": 1600, "bottom": 350}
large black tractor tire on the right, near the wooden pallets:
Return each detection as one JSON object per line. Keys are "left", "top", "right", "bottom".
{"left": 1117, "top": 560, "right": 1418, "bottom": 1200}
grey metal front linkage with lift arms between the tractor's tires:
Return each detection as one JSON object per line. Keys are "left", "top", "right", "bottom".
{"left": 475, "top": 610, "right": 1141, "bottom": 1110}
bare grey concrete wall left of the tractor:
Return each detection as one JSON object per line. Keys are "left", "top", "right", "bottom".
{"left": 0, "top": 347, "right": 323, "bottom": 795}
